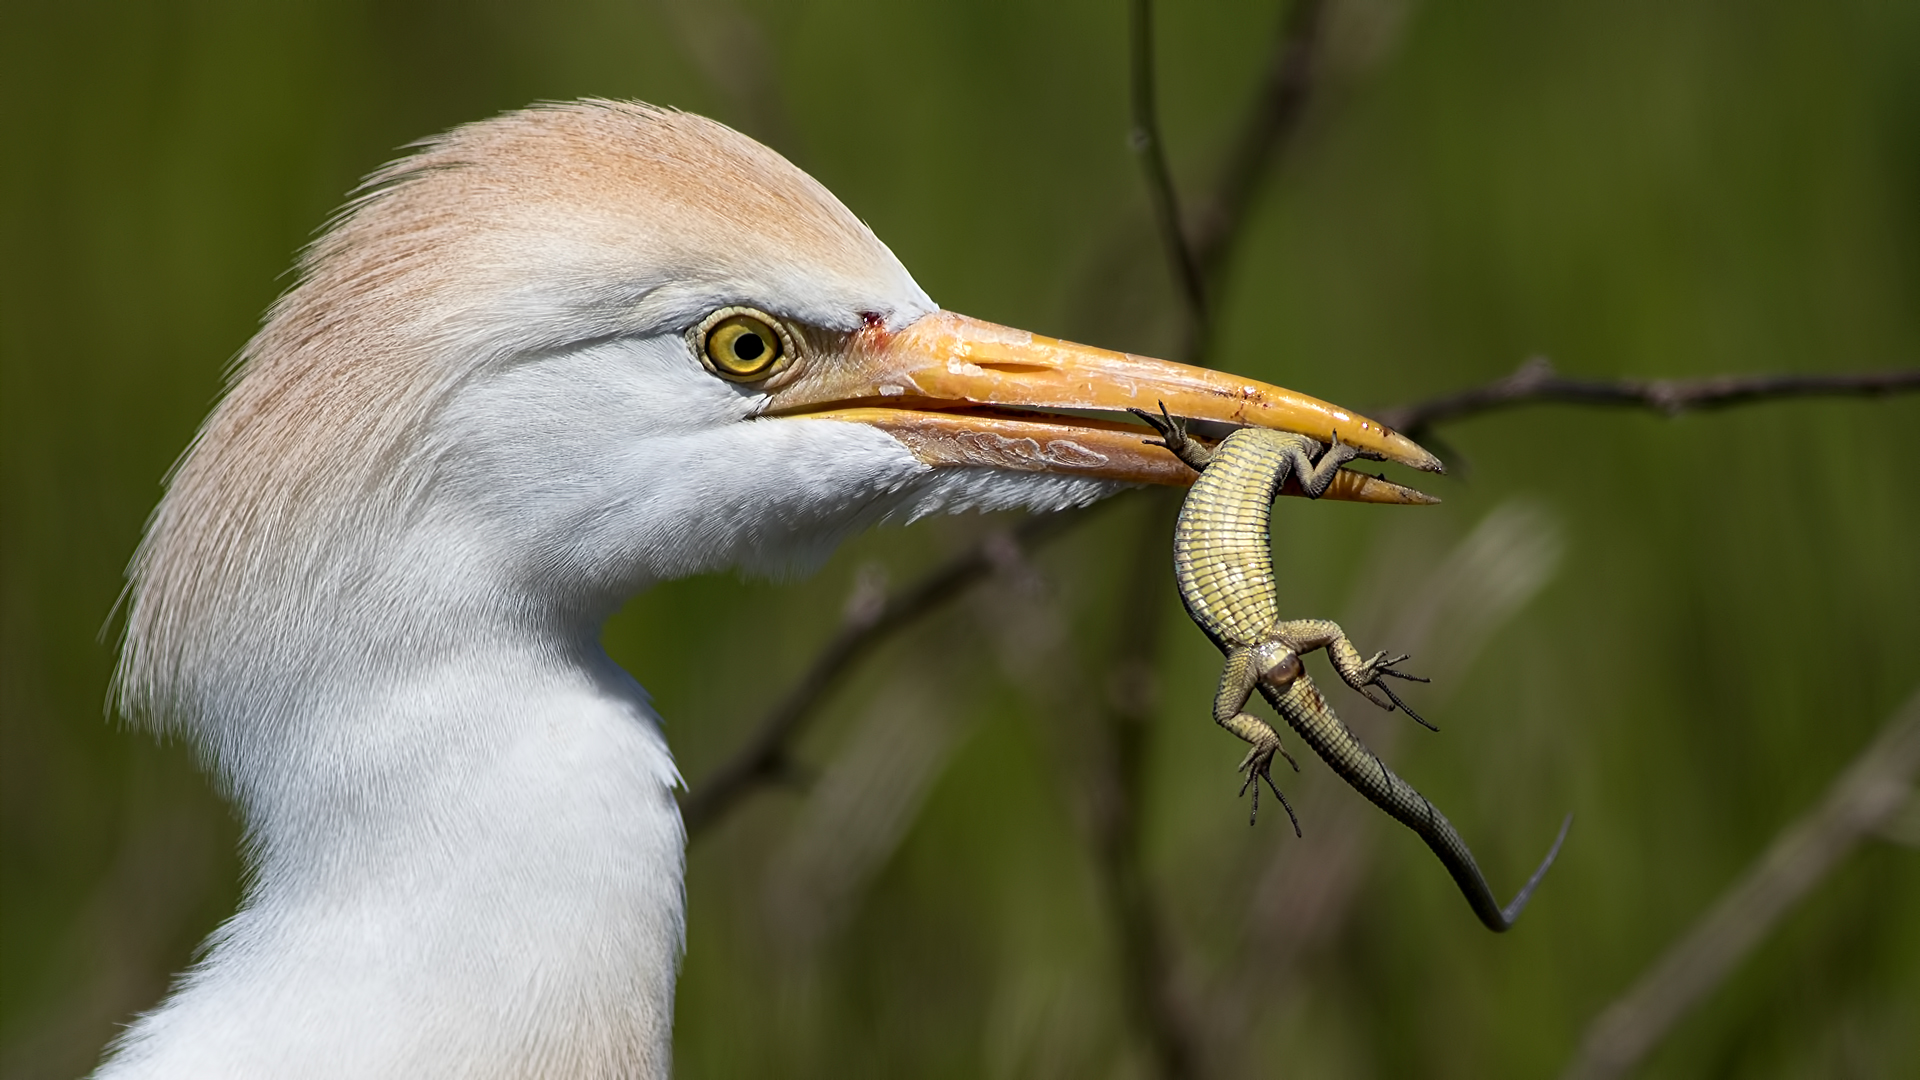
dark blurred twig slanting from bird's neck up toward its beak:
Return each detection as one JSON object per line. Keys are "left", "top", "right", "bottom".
{"left": 680, "top": 511, "right": 1089, "bottom": 838}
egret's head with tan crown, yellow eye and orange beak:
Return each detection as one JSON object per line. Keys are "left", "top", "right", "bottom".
{"left": 121, "top": 102, "right": 1438, "bottom": 753}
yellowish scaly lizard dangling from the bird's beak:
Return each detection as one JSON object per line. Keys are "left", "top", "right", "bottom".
{"left": 1133, "top": 405, "right": 1572, "bottom": 932}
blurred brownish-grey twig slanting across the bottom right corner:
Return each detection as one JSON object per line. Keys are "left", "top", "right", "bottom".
{"left": 1563, "top": 692, "right": 1920, "bottom": 1080}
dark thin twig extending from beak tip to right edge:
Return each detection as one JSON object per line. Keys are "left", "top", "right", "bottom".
{"left": 1375, "top": 356, "right": 1920, "bottom": 438}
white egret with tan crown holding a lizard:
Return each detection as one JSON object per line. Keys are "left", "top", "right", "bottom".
{"left": 98, "top": 102, "right": 1438, "bottom": 1080}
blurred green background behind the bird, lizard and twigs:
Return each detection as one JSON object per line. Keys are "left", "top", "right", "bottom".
{"left": 0, "top": 0, "right": 1920, "bottom": 1078}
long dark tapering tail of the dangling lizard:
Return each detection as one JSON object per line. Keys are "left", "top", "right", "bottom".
{"left": 1260, "top": 673, "right": 1572, "bottom": 932}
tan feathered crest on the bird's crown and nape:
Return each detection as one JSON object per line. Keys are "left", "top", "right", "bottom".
{"left": 117, "top": 102, "right": 924, "bottom": 715}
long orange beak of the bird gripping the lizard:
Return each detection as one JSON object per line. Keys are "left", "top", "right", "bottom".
{"left": 768, "top": 311, "right": 1446, "bottom": 503}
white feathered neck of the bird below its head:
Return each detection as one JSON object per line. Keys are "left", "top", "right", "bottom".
{"left": 100, "top": 614, "right": 684, "bottom": 1078}
